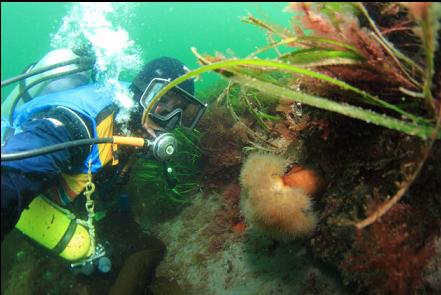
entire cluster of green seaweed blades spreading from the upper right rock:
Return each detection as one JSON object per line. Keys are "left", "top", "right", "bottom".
{"left": 145, "top": 3, "right": 441, "bottom": 143}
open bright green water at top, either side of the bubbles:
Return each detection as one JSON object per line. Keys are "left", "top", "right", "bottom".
{"left": 1, "top": 2, "right": 292, "bottom": 100}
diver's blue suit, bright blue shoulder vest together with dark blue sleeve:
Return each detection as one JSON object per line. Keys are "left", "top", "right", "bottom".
{"left": 1, "top": 84, "right": 124, "bottom": 240}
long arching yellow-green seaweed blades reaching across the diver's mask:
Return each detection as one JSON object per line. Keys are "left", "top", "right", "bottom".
{"left": 153, "top": 59, "right": 441, "bottom": 139}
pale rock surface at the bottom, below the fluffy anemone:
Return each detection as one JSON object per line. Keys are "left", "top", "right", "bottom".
{"left": 151, "top": 195, "right": 343, "bottom": 295}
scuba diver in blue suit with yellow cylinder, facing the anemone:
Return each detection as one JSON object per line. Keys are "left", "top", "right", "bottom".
{"left": 1, "top": 49, "right": 206, "bottom": 272}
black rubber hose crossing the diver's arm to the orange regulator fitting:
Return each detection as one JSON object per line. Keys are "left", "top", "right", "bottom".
{"left": 1, "top": 137, "right": 113, "bottom": 162}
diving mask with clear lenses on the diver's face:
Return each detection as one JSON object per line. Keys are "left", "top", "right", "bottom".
{"left": 139, "top": 78, "right": 207, "bottom": 131}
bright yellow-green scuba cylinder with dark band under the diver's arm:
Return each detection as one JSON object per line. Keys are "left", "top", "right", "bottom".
{"left": 15, "top": 195, "right": 93, "bottom": 261}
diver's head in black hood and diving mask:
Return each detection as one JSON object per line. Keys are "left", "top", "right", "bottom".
{"left": 130, "top": 57, "right": 206, "bottom": 136}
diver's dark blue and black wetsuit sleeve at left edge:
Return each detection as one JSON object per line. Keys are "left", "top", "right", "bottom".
{"left": 1, "top": 112, "right": 87, "bottom": 240}
